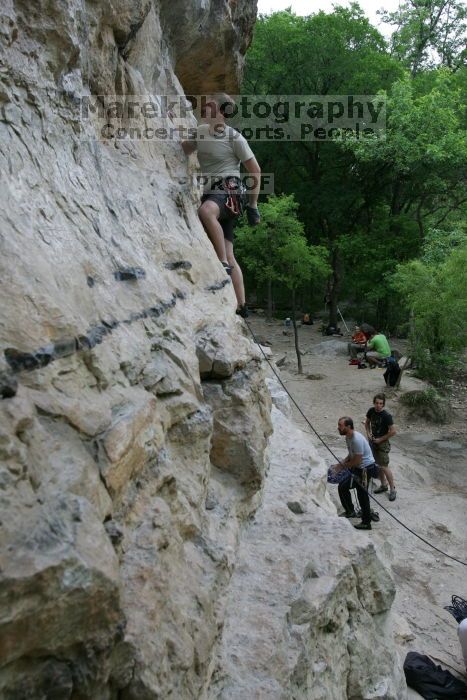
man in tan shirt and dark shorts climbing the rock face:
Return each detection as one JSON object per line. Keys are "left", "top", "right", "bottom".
{"left": 182, "top": 94, "right": 261, "bottom": 317}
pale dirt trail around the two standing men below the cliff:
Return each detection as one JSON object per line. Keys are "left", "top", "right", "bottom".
{"left": 250, "top": 316, "right": 467, "bottom": 680}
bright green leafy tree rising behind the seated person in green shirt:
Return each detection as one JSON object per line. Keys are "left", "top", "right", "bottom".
{"left": 341, "top": 70, "right": 467, "bottom": 325}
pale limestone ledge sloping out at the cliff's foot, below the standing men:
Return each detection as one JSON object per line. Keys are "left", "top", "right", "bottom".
{"left": 207, "top": 400, "right": 406, "bottom": 700}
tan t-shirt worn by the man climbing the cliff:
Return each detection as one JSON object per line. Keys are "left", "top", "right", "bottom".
{"left": 196, "top": 124, "right": 254, "bottom": 192}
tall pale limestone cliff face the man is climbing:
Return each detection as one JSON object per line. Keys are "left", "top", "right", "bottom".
{"left": 0, "top": 0, "right": 402, "bottom": 700}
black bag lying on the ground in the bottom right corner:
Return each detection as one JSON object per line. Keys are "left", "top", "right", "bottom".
{"left": 404, "top": 651, "right": 467, "bottom": 700}
